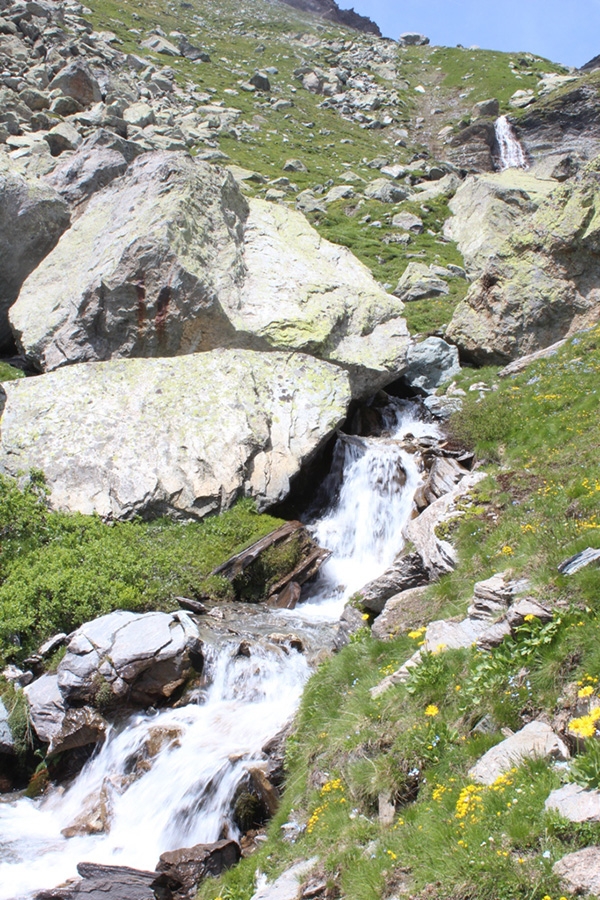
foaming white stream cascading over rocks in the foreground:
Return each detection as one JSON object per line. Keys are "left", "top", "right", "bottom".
{"left": 0, "top": 403, "right": 436, "bottom": 900}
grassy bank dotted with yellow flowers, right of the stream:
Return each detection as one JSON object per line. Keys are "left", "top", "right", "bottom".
{"left": 201, "top": 328, "right": 600, "bottom": 900}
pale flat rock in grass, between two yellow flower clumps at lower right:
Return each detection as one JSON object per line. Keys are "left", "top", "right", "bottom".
{"left": 469, "top": 721, "right": 569, "bottom": 785}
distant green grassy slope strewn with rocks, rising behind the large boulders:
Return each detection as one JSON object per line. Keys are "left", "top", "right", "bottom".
{"left": 81, "top": 0, "right": 560, "bottom": 333}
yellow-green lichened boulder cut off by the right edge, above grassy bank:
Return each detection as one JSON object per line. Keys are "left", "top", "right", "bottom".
{"left": 447, "top": 158, "right": 600, "bottom": 364}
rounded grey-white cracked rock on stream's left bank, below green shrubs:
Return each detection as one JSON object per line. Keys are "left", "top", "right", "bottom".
{"left": 57, "top": 611, "right": 201, "bottom": 707}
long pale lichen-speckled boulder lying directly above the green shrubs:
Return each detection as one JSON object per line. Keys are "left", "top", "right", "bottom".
{"left": 0, "top": 350, "right": 350, "bottom": 518}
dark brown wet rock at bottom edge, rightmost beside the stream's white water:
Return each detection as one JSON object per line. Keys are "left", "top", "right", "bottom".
{"left": 152, "top": 841, "right": 241, "bottom": 900}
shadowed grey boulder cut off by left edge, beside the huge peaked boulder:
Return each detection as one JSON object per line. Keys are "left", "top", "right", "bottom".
{"left": 0, "top": 160, "right": 71, "bottom": 349}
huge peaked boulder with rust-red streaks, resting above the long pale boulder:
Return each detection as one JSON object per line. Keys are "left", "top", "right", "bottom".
{"left": 11, "top": 153, "right": 408, "bottom": 393}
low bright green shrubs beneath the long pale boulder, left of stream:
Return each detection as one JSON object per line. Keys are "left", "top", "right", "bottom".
{"left": 0, "top": 473, "right": 287, "bottom": 661}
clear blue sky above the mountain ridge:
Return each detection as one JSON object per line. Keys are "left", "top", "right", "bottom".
{"left": 346, "top": 0, "right": 600, "bottom": 66}
